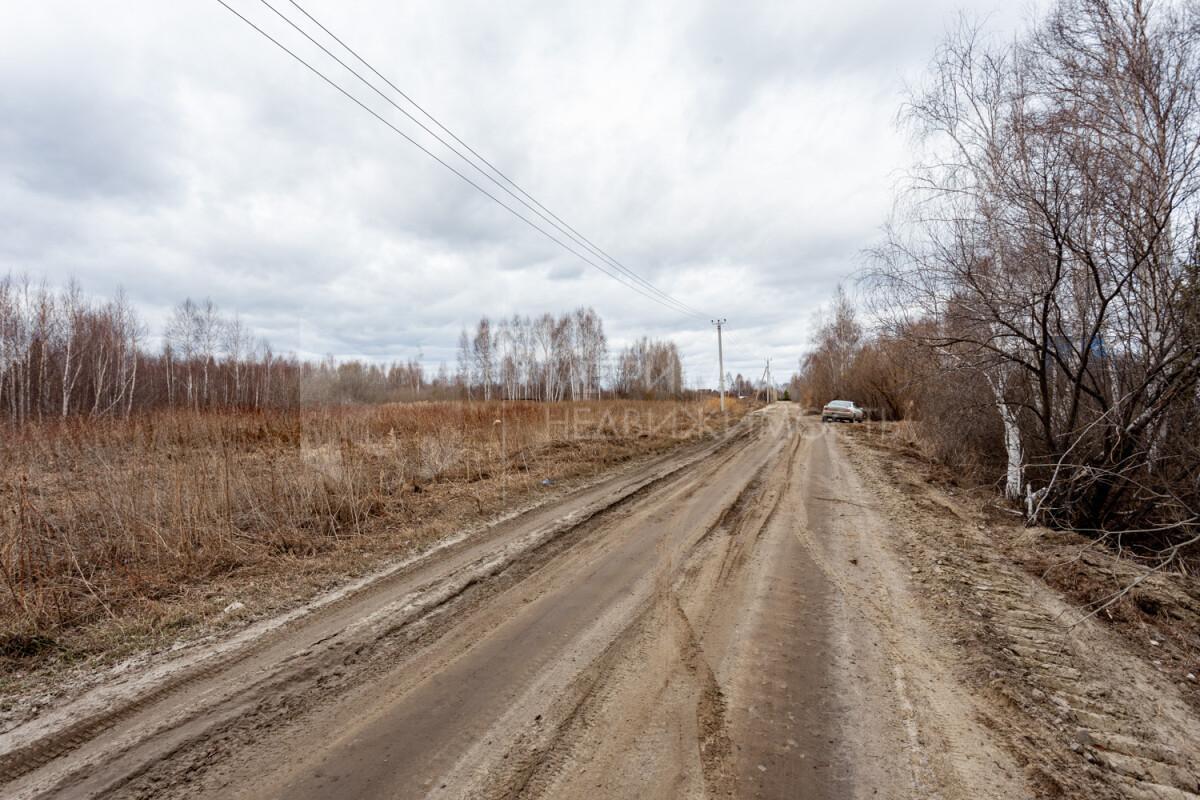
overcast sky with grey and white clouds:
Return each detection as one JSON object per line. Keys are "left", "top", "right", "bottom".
{"left": 0, "top": 0, "right": 1021, "bottom": 385}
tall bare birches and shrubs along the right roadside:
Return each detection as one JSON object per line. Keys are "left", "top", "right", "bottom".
{"left": 798, "top": 0, "right": 1200, "bottom": 553}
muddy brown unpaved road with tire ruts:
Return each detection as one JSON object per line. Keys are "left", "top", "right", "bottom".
{"left": 0, "top": 404, "right": 1200, "bottom": 800}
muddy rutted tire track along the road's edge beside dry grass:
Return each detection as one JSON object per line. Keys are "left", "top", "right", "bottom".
{"left": 0, "top": 420, "right": 758, "bottom": 793}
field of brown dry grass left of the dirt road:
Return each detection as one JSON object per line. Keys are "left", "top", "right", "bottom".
{"left": 0, "top": 401, "right": 742, "bottom": 673}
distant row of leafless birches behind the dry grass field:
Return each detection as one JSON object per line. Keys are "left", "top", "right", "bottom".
{"left": 0, "top": 275, "right": 684, "bottom": 425}
